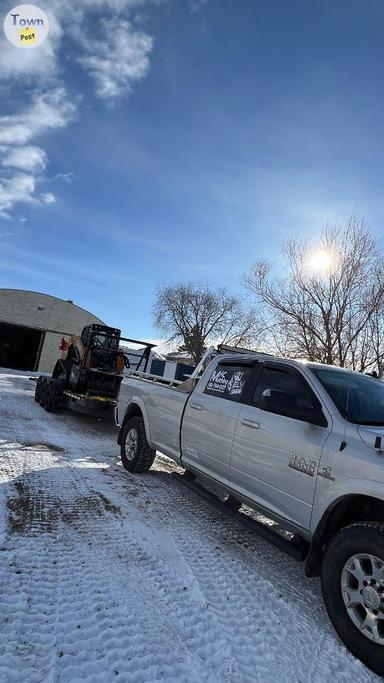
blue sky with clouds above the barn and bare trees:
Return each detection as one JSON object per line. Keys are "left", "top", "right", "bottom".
{"left": 0, "top": 0, "right": 384, "bottom": 338}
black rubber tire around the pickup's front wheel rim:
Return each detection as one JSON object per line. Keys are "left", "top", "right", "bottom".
{"left": 321, "top": 522, "right": 384, "bottom": 676}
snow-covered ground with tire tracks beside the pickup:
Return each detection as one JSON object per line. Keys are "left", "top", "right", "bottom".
{"left": 0, "top": 371, "right": 379, "bottom": 683}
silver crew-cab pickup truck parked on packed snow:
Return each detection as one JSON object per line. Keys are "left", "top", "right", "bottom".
{"left": 118, "top": 350, "right": 384, "bottom": 675}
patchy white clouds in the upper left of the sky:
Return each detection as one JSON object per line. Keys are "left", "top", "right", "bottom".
{"left": 0, "top": 0, "right": 158, "bottom": 218}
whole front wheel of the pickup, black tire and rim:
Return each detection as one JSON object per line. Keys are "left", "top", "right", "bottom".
{"left": 321, "top": 522, "right": 384, "bottom": 676}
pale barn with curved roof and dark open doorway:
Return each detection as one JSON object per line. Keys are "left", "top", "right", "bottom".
{"left": 0, "top": 289, "right": 104, "bottom": 373}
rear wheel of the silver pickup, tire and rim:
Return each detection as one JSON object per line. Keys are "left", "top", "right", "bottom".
{"left": 120, "top": 417, "right": 156, "bottom": 472}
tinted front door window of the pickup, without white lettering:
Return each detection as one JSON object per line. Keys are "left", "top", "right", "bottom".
{"left": 252, "top": 367, "right": 319, "bottom": 419}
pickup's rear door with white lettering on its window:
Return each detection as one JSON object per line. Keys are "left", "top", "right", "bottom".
{"left": 181, "top": 361, "right": 252, "bottom": 484}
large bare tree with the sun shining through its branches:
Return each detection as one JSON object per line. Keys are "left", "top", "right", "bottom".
{"left": 246, "top": 217, "right": 384, "bottom": 371}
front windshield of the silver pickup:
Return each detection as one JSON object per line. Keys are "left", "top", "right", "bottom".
{"left": 311, "top": 368, "right": 384, "bottom": 425}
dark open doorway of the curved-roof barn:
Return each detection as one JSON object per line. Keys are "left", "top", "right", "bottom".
{"left": 0, "top": 323, "right": 45, "bottom": 370}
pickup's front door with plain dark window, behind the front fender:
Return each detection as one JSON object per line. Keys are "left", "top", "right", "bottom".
{"left": 230, "top": 362, "right": 330, "bottom": 529}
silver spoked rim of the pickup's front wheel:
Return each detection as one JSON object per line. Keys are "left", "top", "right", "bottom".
{"left": 341, "top": 553, "right": 384, "bottom": 645}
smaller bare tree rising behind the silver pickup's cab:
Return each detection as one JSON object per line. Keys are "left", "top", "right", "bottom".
{"left": 154, "top": 282, "right": 258, "bottom": 363}
